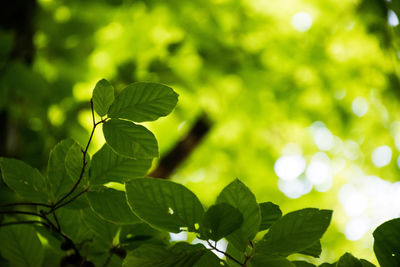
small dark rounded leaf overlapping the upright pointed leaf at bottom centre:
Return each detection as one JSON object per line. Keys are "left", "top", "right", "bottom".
{"left": 200, "top": 203, "right": 243, "bottom": 241}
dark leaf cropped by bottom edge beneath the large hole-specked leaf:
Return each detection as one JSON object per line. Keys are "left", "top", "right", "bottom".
{"left": 122, "top": 242, "right": 207, "bottom": 267}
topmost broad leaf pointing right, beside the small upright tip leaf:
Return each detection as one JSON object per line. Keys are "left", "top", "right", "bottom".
{"left": 108, "top": 82, "right": 178, "bottom": 122}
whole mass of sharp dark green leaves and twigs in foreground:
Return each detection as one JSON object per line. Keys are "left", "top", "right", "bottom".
{"left": 0, "top": 79, "right": 400, "bottom": 267}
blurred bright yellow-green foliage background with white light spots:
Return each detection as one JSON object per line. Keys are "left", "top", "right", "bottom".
{"left": 0, "top": 0, "right": 400, "bottom": 263}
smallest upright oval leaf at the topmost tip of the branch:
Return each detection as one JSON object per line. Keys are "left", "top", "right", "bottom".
{"left": 92, "top": 79, "right": 114, "bottom": 116}
